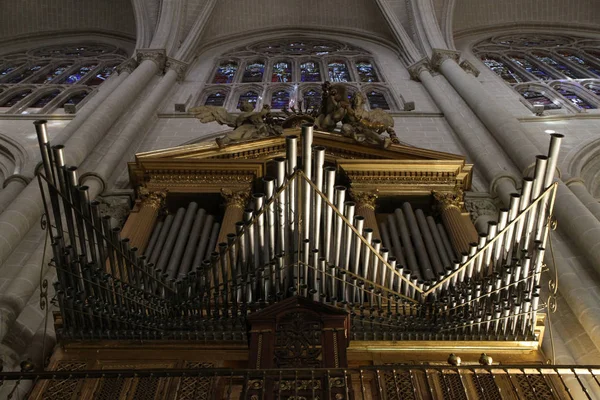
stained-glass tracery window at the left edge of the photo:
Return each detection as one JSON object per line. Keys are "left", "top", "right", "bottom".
{"left": 0, "top": 43, "right": 127, "bottom": 114}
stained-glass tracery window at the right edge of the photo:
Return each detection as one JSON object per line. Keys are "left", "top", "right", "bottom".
{"left": 474, "top": 34, "right": 600, "bottom": 111}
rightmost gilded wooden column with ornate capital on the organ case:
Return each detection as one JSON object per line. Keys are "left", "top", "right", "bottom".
{"left": 432, "top": 191, "right": 478, "bottom": 254}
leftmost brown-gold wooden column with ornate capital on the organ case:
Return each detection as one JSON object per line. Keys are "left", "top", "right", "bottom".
{"left": 121, "top": 187, "right": 167, "bottom": 254}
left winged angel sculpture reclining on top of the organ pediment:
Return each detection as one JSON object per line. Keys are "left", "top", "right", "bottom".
{"left": 189, "top": 101, "right": 283, "bottom": 147}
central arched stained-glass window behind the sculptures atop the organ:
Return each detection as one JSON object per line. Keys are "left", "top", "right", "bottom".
{"left": 203, "top": 38, "right": 396, "bottom": 111}
